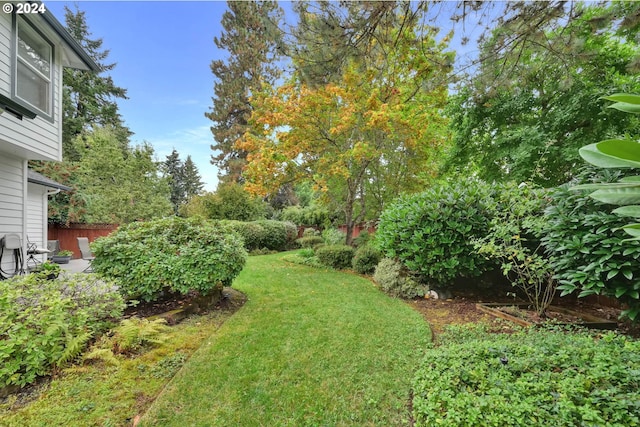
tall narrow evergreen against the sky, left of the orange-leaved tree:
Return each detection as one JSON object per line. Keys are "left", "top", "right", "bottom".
{"left": 205, "top": 0, "right": 283, "bottom": 182}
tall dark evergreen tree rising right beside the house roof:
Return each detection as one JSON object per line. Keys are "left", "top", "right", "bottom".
{"left": 62, "top": 6, "right": 132, "bottom": 161}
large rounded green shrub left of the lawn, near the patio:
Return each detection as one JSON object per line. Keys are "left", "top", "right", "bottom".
{"left": 92, "top": 217, "right": 247, "bottom": 301}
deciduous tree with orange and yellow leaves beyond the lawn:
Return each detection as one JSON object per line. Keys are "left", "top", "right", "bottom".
{"left": 236, "top": 8, "right": 451, "bottom": 243}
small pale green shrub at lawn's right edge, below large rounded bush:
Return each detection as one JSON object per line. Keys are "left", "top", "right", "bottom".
{"left": 373, "top": 258, "right": 428, "bottom": 298}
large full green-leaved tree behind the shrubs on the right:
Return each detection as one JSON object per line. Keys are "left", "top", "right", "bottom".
{"left": 446, "top": 5, "right": 640, "bottom": 187}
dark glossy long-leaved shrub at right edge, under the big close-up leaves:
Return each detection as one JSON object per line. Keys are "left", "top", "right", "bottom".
{"left": 542, "top": 168, "right": 640, "bottom": 318}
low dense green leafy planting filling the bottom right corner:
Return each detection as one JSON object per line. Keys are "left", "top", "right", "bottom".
{"left": 413, "top": 328, "right": 640, "bottom": 427}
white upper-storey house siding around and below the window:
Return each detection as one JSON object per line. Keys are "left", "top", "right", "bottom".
{"left": 0, "top": 11, "right": 62, "bottom": 160}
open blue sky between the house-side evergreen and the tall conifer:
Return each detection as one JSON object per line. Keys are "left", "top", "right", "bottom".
{"left": 45, "top": 1, "right": 232, "bottom": 191}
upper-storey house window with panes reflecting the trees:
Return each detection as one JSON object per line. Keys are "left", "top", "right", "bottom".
{"left": 14, "top": 17, "right": 53, "bottom": 117}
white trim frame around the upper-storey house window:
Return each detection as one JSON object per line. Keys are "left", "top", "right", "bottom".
{"left": 11, "top": 12, "right": 56, "bottom": 123}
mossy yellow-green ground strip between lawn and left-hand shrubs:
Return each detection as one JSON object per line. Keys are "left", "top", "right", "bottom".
{"left": 0, "top": 300, "right": 244, "bottom": 427}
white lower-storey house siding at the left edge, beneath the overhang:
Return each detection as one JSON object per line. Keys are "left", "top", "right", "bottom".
{"left": 0, "top": 156, "right": 26, "bottom": 272}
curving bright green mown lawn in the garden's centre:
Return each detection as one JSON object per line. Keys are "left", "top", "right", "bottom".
{"left": 141, "top": 254, "right": 431, "bottom": 427}
